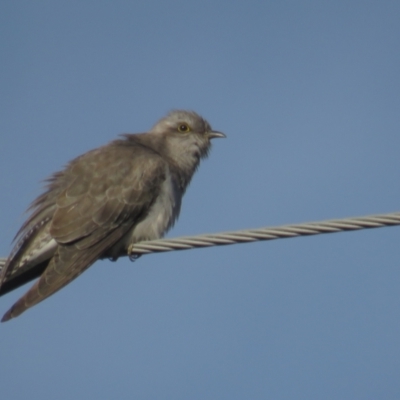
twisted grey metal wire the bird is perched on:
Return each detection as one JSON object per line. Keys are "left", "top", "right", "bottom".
{"left": 0, "top": 212, "right": 400, "bottom": 270}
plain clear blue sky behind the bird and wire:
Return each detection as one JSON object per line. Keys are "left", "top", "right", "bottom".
{"left": 0, "top": 0, "right": 400, "bottom": 400}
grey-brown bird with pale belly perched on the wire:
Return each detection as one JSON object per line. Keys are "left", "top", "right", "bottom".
{"left": 0, "top": 110, "right": 225, "bottom": 322}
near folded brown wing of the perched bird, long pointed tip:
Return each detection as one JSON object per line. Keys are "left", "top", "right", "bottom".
{"left": 3, "top": 142, "right": 167, "bottom": 320}
